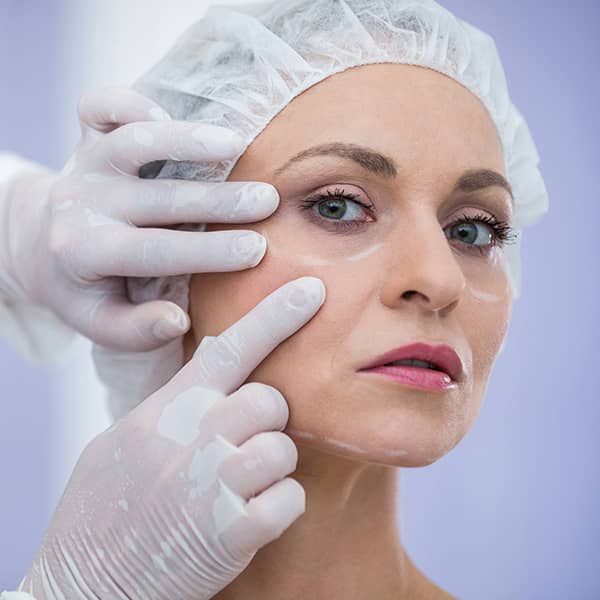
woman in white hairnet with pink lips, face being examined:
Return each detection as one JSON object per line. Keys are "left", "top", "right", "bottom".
{"left": 12, "top": 0, "right": 547, "bottom": 599}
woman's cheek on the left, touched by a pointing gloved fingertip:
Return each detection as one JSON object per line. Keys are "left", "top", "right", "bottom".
{"left": 190, "top": 223, "right": 379, "bottom": 397}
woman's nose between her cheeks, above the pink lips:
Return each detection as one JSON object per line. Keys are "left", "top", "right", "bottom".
{"left": 380, "top": 220, "right": 466, "bottom": 312}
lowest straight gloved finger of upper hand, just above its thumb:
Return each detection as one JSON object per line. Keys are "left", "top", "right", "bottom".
{"left": 78, "top": 225, "right": 267, "bottom": 278}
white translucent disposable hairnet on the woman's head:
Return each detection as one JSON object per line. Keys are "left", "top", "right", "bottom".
{"left": 135, "top": 0, "right": 548, "bottom": 298}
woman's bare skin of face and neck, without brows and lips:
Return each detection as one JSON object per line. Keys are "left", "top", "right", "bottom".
{"left": 185, "top": 64, "right": 512, "bottom": 599}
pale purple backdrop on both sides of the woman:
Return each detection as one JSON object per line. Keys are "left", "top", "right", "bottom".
{"left": 0, "top": 0, "right": 600, "bottom": 600}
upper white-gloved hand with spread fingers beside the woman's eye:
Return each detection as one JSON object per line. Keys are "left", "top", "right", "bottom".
{"left": 0, "top": 88, "right": 279, "bottom": 351}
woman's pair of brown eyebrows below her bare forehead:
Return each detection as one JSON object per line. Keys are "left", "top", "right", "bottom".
{"left": 274, "top": 142, "right": 514, "bottom": 202}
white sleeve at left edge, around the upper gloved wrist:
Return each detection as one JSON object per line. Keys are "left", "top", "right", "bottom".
{"left": 0, "top": 154, "right": 74, "bottom": 364}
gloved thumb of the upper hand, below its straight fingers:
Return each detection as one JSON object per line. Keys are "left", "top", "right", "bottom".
{"left": 75, "top": 296, "right": 190, "bottom": 352}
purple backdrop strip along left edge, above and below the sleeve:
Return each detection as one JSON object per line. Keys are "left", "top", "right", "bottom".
{"left": 0, "top": 0, "right": 63, "bottom": 591}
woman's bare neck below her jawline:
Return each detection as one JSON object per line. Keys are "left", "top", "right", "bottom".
{"left": 214, "top": 443, "right": 448, "bottom": 600}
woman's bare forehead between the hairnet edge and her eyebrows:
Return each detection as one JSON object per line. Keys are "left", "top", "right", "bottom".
{"left": 241, "top": 64, "right": 504, "bottom": 172}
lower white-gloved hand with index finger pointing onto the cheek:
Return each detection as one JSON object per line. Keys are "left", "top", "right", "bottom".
{"left": 19, "top": 277, "right": 325, "bottom": 600}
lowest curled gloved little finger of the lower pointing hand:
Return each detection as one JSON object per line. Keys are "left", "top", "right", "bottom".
{"left": 220, "top": 477, "right": 306, "bottom": 561}
